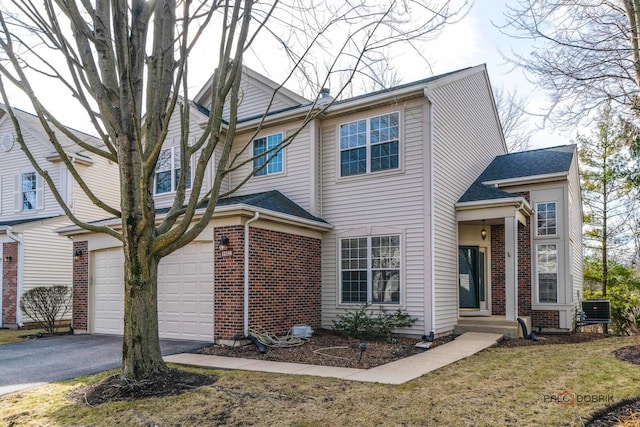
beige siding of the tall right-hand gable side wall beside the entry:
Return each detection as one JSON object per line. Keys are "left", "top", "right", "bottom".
{"left": 430, "top": 72, "right": 506, "bottom": 333}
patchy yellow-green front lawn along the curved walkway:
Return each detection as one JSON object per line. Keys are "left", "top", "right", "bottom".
{"left": 0, "top": 338, "right": 640, "bottom": 427}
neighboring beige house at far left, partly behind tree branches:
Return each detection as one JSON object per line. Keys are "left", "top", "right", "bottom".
{"left": 0, "top": 106, "right": 119, "bottom": 327}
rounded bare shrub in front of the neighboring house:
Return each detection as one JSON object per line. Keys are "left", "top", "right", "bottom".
{"left": 20, "top": 285, "right": 71, "bottom": 335}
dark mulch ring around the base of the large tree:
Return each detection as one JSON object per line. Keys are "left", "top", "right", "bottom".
{"left": 67, "top": 369, "right": 218, "bottom": 406}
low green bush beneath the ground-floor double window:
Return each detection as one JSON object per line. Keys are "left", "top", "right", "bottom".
{"left": 333, "top": 304, "right": 417, "bottom": 339}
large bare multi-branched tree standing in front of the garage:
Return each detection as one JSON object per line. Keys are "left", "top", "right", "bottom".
{"left": 0, "top": 0, "right": 468, "bottom": 379}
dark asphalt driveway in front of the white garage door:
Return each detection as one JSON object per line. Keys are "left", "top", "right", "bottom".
{"left": 0, "top": 335, "right": 207, "bottom": 395}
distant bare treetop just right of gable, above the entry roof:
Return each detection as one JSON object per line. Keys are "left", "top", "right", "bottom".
{"left": 493, "top": 88, "right": 535, "bottom": 153}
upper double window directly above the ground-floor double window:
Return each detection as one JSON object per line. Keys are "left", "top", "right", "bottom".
{"left": 340, "top": 113, "right": 400, "bottom": 176}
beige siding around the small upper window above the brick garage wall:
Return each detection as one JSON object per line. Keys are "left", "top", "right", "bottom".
{"left": 230, "top": 124, "right": 313, "bottom": 210}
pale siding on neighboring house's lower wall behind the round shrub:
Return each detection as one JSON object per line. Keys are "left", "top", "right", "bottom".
{"left": 16, "top": 218, "right": 73, "bottom": 322}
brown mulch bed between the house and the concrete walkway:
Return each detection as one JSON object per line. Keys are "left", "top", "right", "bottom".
{"left": 196, "top": 329, "right": 455, "bottom": 369}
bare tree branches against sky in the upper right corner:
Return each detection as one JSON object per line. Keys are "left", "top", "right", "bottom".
{"left": 502, "top": 0, "right": 640, "bottom": 124}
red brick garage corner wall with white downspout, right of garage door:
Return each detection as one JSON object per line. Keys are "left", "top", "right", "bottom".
{"left": 214, "top": 226, "right": 321, "bottom": 339}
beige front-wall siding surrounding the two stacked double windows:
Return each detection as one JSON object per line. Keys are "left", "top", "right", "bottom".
{"left": 321, "top": 100, "right": 427, "bottom": 334}
